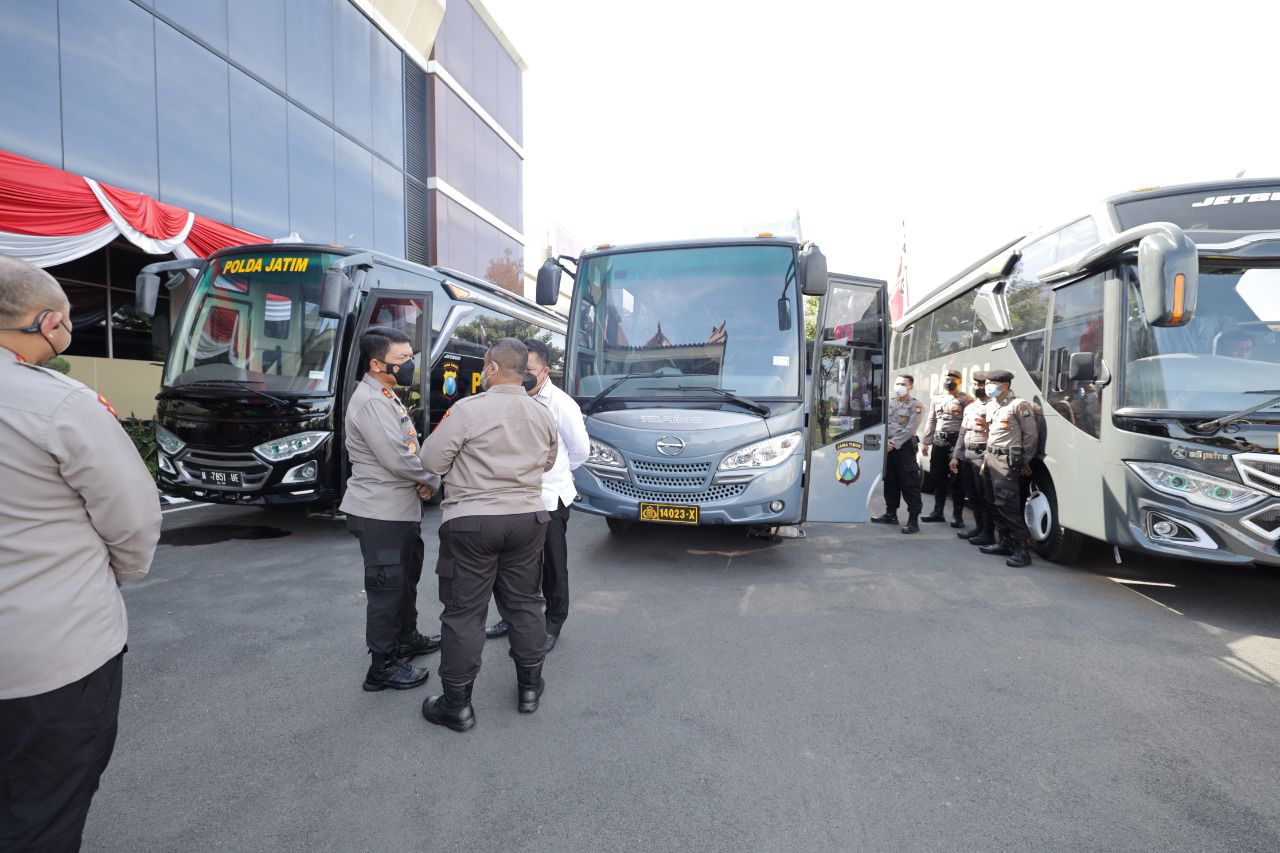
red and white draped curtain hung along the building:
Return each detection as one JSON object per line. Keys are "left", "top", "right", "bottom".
{"left": 0, "top": 151, "right": 266, "bottom": 266}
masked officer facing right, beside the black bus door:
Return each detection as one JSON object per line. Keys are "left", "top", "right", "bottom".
{"left": 340, "top": 327, "right": 440, "bottom": 690}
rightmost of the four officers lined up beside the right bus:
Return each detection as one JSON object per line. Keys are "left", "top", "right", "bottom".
{"left": 980, "top": 370, "right": 1039, "bottom": 567}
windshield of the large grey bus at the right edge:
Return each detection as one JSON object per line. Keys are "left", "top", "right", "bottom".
{"left": 1123, "top": 266, "right": 1280, "bottom": 414}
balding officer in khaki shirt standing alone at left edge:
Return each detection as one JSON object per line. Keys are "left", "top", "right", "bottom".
{"left": 0, "top": 256, "right": 160, "bottom": 850}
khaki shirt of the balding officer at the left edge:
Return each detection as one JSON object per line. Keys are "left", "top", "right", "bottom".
{"left": 0, "top": 348, "right": 160, "bottom": 699}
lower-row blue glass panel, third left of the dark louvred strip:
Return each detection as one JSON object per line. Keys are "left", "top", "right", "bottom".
{"left": 289, "top": 104, "right": 335, "bottom": 243}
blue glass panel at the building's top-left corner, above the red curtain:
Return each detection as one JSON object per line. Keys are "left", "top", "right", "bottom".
{"left": 0, "top": 0, "right": 63, "bottom": 167}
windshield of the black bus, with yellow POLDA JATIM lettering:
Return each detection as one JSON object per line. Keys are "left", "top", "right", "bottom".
{"left": 164, "top": 251, "right": 338, "bottom": 394}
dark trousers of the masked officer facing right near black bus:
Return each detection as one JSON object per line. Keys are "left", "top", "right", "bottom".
{"left": 347, "top": 515, "right": 424, "bottom": 654}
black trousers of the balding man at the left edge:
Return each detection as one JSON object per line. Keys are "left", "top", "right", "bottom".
{"left": 0, "top": 652, "right": 124, "bottom": 853}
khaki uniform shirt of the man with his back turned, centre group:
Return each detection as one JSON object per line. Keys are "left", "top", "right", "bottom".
{"left": 420, "top": 384, "right": 558, "bottom": 521}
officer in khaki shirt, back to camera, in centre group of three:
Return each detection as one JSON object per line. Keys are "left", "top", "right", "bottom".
{"left": 421, "top": 338, "right": 558, "bottom": 731}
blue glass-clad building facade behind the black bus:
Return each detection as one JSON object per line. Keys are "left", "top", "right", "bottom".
{"left": 0, "top": 0, "right": 524, "bottom": 416}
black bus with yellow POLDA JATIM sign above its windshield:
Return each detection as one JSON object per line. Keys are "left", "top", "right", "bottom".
{"left": 137, "top": 243, "right": 564, "bottom": 506}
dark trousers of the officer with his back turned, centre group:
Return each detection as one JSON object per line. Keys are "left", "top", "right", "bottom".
{"left": 435, "top": 511, "right": 549, "bottom": 681}
